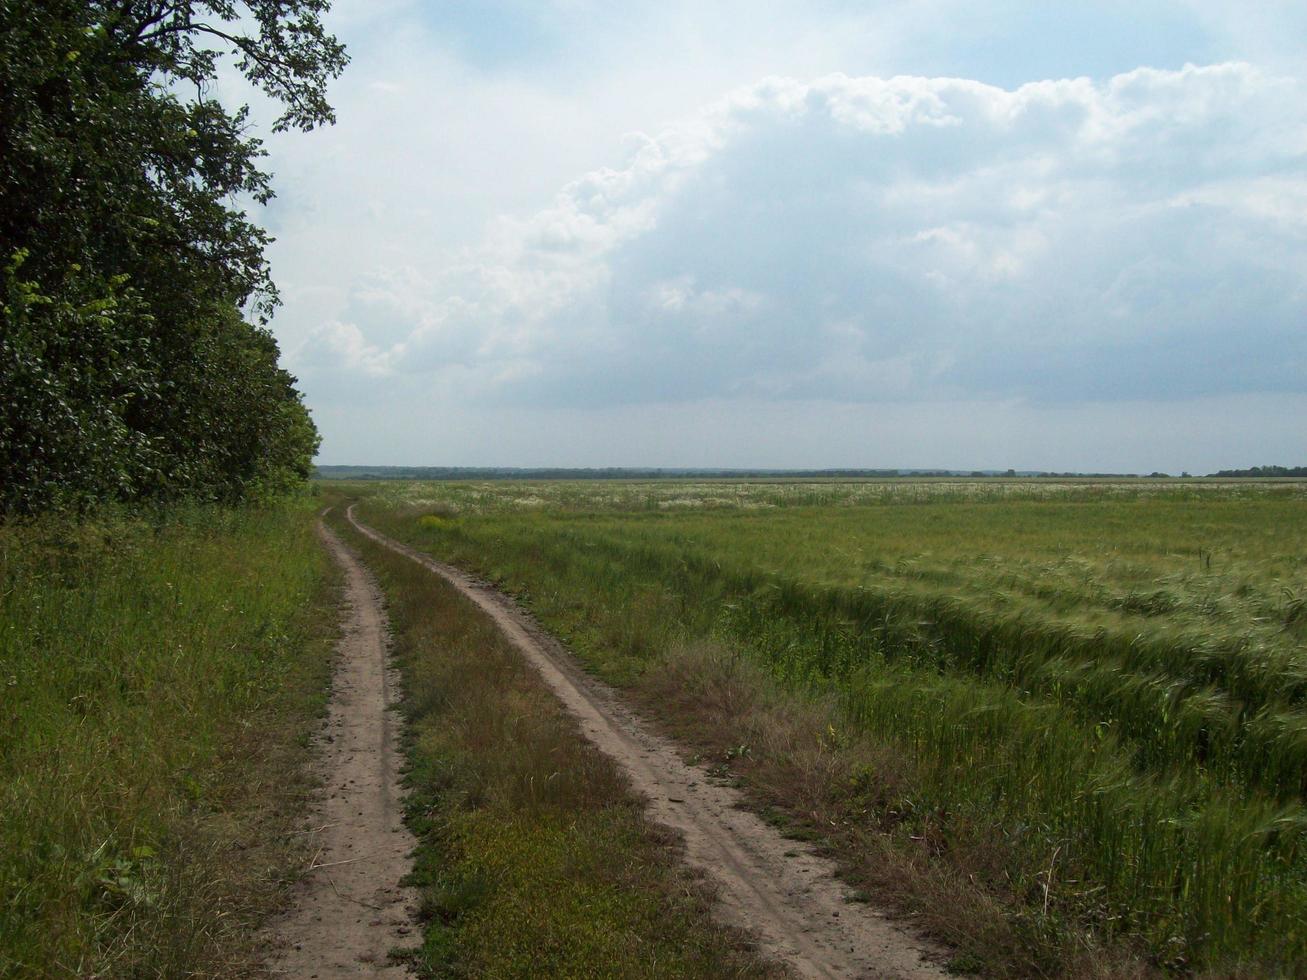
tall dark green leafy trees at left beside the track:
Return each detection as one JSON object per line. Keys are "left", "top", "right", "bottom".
{"left": 0, "top": 0, "right": 346, "bottom": 514}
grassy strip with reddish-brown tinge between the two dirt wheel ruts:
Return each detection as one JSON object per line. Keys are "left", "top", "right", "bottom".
{"left": 324, "top": 501, "right": 782, "bottom": 977}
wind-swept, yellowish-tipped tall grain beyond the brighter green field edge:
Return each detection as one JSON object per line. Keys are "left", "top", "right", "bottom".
{"left": 376, "top": 485, "right": 1307, "bottom": 800}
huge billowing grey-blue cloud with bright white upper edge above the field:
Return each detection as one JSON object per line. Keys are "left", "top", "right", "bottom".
{"left": 295, "top": 64, "right": 1307, "bottom": 406}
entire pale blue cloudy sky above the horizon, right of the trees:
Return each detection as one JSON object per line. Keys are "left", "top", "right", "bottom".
{"left": 240, "top": 0, "right": 1307, "bottom": 473}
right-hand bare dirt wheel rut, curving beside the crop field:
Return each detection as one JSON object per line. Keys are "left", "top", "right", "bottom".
{"left": 346, "top": 506, "right": 946, "bottom": 977}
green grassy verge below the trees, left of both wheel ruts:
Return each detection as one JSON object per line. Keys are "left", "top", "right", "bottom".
{"left": 0, "top": 500, "right": 336, "bottom": 977}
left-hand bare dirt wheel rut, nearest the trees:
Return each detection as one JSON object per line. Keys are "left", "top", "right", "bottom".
{"left": 268, "top": 524, "right": 417, "bottom": 980}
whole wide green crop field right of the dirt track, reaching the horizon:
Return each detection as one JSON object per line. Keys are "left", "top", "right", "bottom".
{"left": 350, "top": 480, "right": 1307, "bottom": 975}
